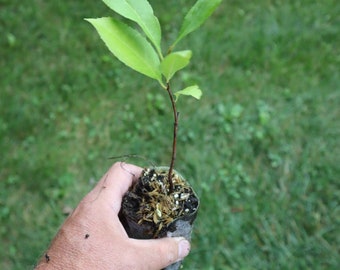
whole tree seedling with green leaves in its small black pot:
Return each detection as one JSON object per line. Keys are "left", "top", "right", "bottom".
{"left": 86, "top": 0, "right": 222, "bottom": 269}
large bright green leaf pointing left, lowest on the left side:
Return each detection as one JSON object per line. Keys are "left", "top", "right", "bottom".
{"left": 85, "top": 17, "right": 162, "bottom": 81}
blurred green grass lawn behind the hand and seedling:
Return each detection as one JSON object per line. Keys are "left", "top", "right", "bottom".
{"left": 0, "top": 0, "right": 340, "bottom": 270}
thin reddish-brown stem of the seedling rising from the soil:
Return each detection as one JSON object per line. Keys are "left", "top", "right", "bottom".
{"left": 166, "top": 83, "right": 179, "bottom": 193}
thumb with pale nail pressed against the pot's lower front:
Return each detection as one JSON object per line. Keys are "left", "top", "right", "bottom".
{"left": 131, "top": 237, "right": 190, "bottom": 270}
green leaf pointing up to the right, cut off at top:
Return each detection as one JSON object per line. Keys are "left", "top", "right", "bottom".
{"left": 171, "top": 0, "right": 222, "bottom": 48}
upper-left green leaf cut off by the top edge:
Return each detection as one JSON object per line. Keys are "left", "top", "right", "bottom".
{"left": 103, "top": 0, "right": 161, "bottom": 55}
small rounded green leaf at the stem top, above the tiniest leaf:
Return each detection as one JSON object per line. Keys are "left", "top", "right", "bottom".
{"left": 161, "top": 50, "right": 192, "bottom": 82}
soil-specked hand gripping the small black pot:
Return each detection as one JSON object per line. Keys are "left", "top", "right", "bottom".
{"left": 36, "top": 162, "right": 190, "bottom": 270}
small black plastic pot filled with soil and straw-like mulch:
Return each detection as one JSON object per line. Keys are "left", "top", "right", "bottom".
{"left": 119, "top": 167, "right": 199, "bottom": 270}
